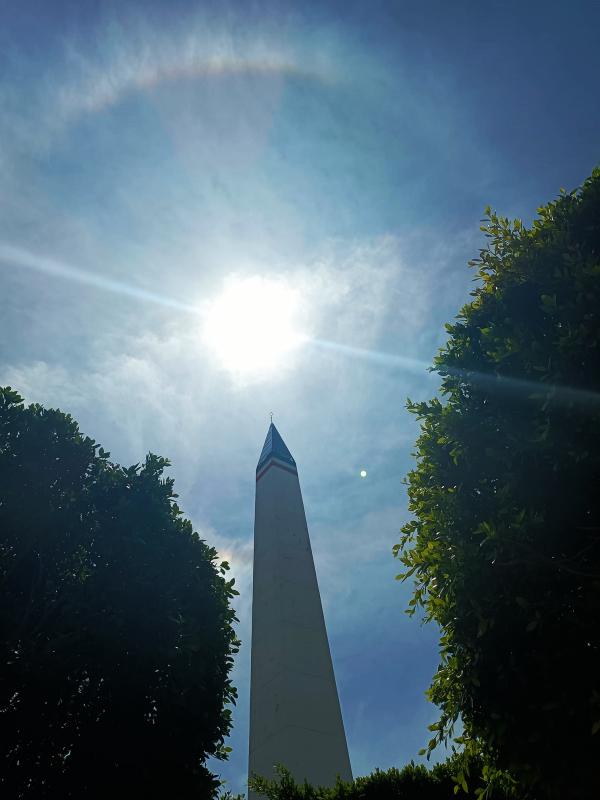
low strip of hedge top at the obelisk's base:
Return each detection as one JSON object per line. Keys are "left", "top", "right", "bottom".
{"left": 249, "top": 756, "right": 514, "bottom": 800}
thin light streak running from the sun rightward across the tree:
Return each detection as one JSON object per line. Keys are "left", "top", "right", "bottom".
{"left": 306, "top": 339, "right": 600, "bottom": 409}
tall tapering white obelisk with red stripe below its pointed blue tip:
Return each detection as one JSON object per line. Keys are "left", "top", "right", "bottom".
{"left": 249, "top": 423, "right": 352, "bottom": 798}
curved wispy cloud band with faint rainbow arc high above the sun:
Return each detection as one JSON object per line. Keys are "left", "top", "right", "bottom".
{"left": 0, "top": 13, "right": 336, "bottom": 159}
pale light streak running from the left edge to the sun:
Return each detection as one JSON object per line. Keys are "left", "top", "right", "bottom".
{"left": 0, "top": 243, "right": 199, "bottom": 314}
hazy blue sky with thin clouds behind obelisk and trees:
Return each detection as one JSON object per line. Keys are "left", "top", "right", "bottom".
{"left": 0, "top": 0, "right": 600, "bottom": 791}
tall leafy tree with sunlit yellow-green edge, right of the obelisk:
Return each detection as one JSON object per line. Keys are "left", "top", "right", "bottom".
{"left": 396, "top": 170, "right": 600, "bottom": 798}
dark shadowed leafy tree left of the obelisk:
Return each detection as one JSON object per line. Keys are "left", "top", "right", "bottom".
{"left": 0, "top": 389, "right": 237, "bottom": 800}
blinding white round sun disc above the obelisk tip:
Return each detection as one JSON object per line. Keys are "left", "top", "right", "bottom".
{"left": 203, "top": 277, "right": 302, "bottom": 375}
